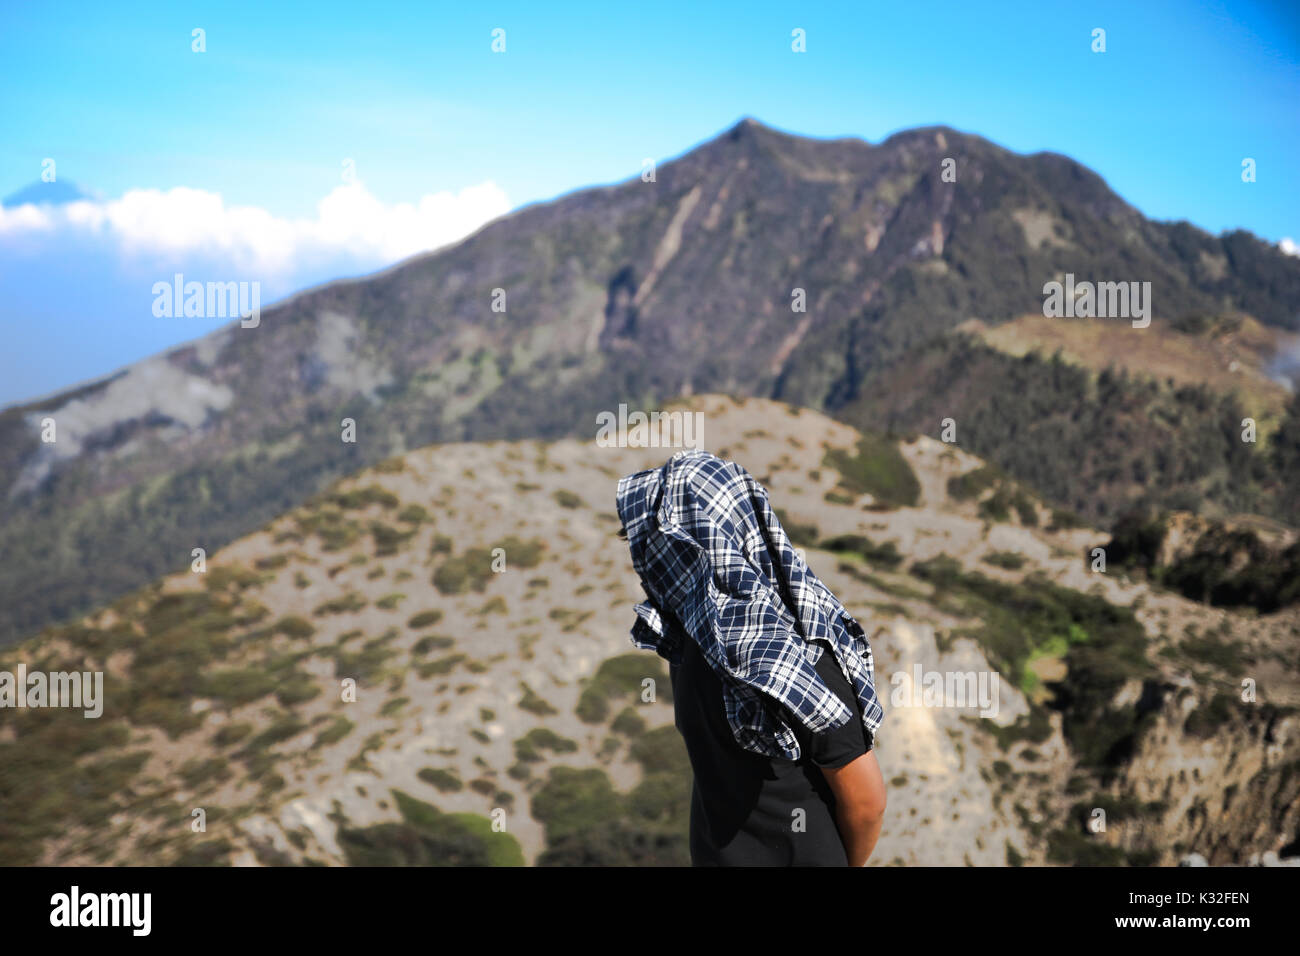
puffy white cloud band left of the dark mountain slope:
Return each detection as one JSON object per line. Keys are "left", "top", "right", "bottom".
{"left": 0, "top": 181, "right": 510, "bottom": 277}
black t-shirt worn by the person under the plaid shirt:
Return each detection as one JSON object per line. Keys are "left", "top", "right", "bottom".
{"left": 670, "top": 637, "right": 871, "bottom": 866}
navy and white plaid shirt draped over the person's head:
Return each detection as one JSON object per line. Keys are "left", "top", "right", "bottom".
{"left": 618, "top": 449, "right": 884, "bottom": 760}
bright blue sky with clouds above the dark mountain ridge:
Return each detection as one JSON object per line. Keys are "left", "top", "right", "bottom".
{"left": 0, "top": 0, "right": 1300, "bottom": 405}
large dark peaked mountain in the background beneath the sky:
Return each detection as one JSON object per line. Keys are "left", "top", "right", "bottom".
{"left": 0, "top": 120, "right": 1300, "bottom": 643}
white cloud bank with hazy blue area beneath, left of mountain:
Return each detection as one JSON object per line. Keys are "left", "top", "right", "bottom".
{"left": 0, "top": 181, "right": 510, "bottom": 407}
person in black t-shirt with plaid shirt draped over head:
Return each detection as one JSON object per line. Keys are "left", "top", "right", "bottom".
{"left": 618, "top": 450, "right": 887, "bottom": 866}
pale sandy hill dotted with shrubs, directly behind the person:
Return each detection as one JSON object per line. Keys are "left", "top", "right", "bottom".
{"left": 0, "top": 395, "right": 1300, "bottom": 865}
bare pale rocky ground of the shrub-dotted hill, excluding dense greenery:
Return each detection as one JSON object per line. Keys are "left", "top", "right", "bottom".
{"left": 10, "top": 395, "right": 1300, "bottom": 865}
